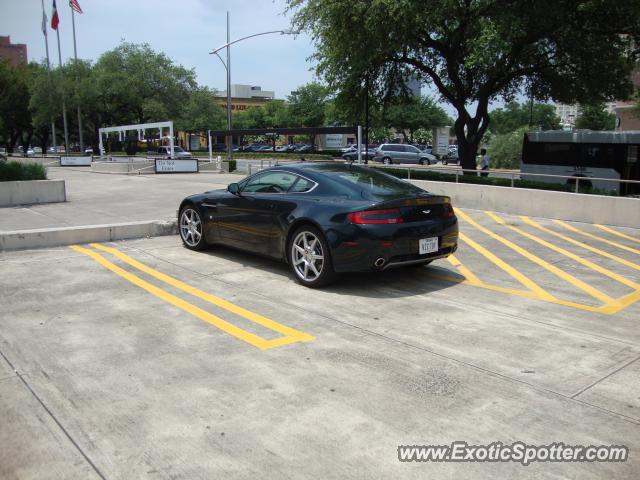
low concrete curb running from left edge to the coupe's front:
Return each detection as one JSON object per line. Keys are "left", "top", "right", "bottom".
{"left": 0, "top": 220, "right": 178, "bottom": 251}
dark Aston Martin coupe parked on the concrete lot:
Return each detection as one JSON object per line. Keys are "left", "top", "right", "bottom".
{"left": 178, "top": 162, "right": 458, "bottom": 287}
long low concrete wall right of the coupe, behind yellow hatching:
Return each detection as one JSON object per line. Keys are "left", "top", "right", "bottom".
{"left": 411, "top": 180, "right": 640, "bottom": 228}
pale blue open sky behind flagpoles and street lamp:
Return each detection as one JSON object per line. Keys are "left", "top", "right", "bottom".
{"left": 0, "top": 0, "right": 315, "bottom": 98}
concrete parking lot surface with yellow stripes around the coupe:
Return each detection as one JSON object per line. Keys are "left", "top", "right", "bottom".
{"left": 0, "top": 205, "right": 640, "bottom": 479}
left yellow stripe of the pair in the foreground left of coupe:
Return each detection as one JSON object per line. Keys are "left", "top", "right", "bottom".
{"left": 69, "top": 245, "right": 310, "bottom": 350}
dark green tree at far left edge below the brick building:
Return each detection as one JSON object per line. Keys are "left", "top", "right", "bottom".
{"left": 0, "top": 60, "right": 33, "bottom": 152}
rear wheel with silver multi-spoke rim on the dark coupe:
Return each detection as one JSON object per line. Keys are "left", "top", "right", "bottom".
{"left": 287, "top": 225, "right": 337, "bottom": 288}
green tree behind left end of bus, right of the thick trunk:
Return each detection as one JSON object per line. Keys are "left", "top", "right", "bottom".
{"left": 489, "top": 102, "right": 560, "bottom": 134}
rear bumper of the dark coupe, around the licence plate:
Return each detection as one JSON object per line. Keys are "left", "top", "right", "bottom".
{"left": 325, "top": 218, "right": 458, "bottom": 272}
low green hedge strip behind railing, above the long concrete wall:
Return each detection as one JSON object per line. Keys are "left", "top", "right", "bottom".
{"left": 384, "top": 168, "right": 615, "bottom": 196}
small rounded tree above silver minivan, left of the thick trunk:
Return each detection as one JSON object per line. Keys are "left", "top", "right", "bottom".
{"left": 384, "top": 96, "right": 452, "bottom": 143}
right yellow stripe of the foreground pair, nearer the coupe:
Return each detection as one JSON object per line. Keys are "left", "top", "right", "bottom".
{"left": 91, "top": 243, "right": 314, "bottom": 342}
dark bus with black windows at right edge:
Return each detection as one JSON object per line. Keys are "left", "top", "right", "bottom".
{"left": 520, "top": 130, "right": 640, "bottom": 196}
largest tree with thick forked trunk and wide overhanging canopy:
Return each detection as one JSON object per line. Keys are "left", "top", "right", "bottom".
{"left": 287, "top": 0, "right": 640, "bottom": 172}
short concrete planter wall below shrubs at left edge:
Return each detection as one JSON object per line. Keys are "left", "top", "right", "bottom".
{"left": 0, "top": 180, "right": 67, "bottom": 207}
